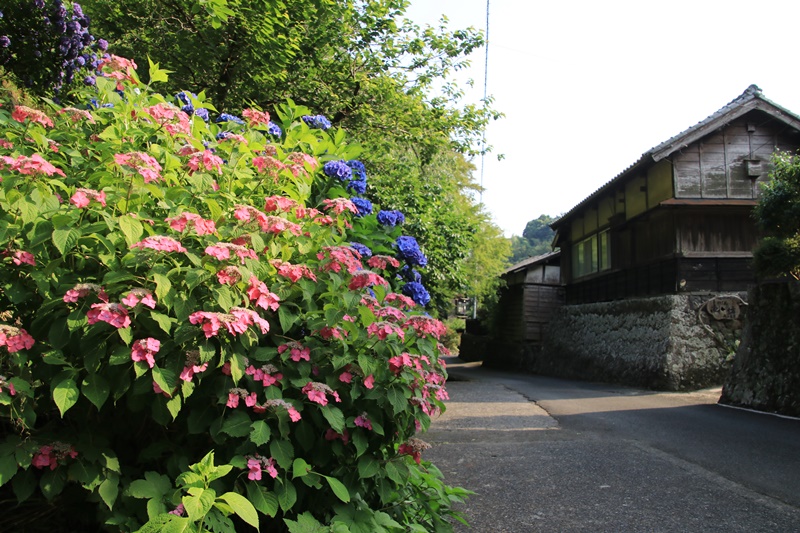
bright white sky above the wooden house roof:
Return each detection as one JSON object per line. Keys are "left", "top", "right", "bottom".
{"left": 406, "top": 0, "right": 800, "bottom": 236}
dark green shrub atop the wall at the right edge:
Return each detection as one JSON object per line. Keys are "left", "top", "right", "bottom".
{"left": 753, "top": 153, "right": 800, "bottom": 279}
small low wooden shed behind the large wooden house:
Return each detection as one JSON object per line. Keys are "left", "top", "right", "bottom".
{"left": 497, "top": 252, "right": 564, "bottom": 346}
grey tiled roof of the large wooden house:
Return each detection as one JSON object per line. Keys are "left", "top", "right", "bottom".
{"left": 550, "top": 85, "right": 800, "bottom": 228}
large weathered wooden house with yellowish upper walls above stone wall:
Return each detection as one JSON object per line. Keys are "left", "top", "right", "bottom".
{"left": 551, "top": 85, "right": 800, "bottom": 304}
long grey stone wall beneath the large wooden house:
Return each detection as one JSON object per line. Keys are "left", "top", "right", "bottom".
{"left": 484, "top": 294, "right": 747, "bottom": 390}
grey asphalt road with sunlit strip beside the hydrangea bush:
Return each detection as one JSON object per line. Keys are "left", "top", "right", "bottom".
{"left": 423, "top": 359, "right": 800, "bottom": 533}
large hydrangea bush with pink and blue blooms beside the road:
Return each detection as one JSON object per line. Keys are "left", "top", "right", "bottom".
{"left": 0, "top": 56, "right": 465, "bottom": 532}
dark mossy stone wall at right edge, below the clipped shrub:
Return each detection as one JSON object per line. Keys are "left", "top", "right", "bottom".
{"left": 720, "top": 282, "right": 800, "bottom": 416}
